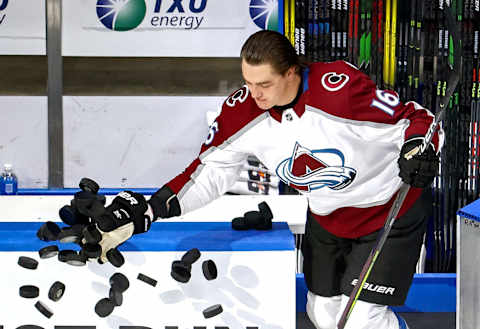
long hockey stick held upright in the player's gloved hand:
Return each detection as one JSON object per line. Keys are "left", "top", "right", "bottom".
{"left": 337, "top": 3, "right": 461, "bottom": 329}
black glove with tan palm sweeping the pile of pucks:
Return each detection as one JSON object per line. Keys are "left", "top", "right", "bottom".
{"left": 94, "top": 191, "right": 152, "bottom": 263}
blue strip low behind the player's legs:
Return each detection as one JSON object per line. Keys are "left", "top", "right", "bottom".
{"left": 296, "top": 273, "right": 456, "bottom": 312}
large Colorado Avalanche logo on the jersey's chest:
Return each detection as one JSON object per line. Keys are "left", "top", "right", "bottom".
{"left": 277, "top": 143, "right": 357, "bottom": 192}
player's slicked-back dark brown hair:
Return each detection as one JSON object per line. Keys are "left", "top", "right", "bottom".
{"left": 240, "top": 30, "right": 301, "bottom": 75}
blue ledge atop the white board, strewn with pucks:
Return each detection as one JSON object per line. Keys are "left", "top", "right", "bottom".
{"left": 0, "top": 222, "right": 295, "bottom": 251}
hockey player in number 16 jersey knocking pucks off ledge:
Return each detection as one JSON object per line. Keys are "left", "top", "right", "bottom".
{"left": 89, "top": 31, "right": 443, "bottom": 329}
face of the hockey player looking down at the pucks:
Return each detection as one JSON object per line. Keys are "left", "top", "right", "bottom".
{"left": 242, "top": 60, "right": 291, "bottom": 110}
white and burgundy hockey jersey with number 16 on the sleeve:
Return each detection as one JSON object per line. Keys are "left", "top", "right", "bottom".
{"left": 167, "top": 61, "right": 443, "bottom": 238}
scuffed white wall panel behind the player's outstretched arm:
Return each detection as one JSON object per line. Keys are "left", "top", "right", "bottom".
{"left": 63, "top": 96, "right": 224, "bottom": 188}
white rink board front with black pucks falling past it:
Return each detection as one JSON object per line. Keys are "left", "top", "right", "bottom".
{"left": 0, "top": 250, "right": 295, "bottom": 329}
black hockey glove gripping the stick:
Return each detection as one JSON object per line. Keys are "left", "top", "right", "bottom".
{"left": 398, "top": 138, "right": 439, "bottom": 188}
